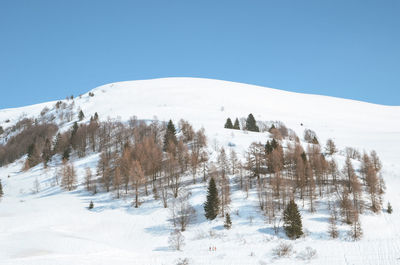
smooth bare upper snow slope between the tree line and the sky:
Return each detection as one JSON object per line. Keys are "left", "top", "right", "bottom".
{"left": 0, "top": 78, "right": 400, "bottom": 163}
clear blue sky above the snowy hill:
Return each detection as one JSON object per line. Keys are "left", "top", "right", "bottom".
{"left": 0, "top": 0, "right": 400, "bottom": 108}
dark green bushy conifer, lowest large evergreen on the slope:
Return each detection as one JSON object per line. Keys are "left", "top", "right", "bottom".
{"left": 283, "top": 200, "right": 303, "bottom": 239}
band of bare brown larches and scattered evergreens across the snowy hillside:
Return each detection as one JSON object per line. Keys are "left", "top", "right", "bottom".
{"left": 0, "top": 98, "right": 392, "bottom": 245}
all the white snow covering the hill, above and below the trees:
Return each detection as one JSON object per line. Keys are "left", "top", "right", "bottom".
{"left": 0, "top": 78, "right": 400, "bottom": 265}
